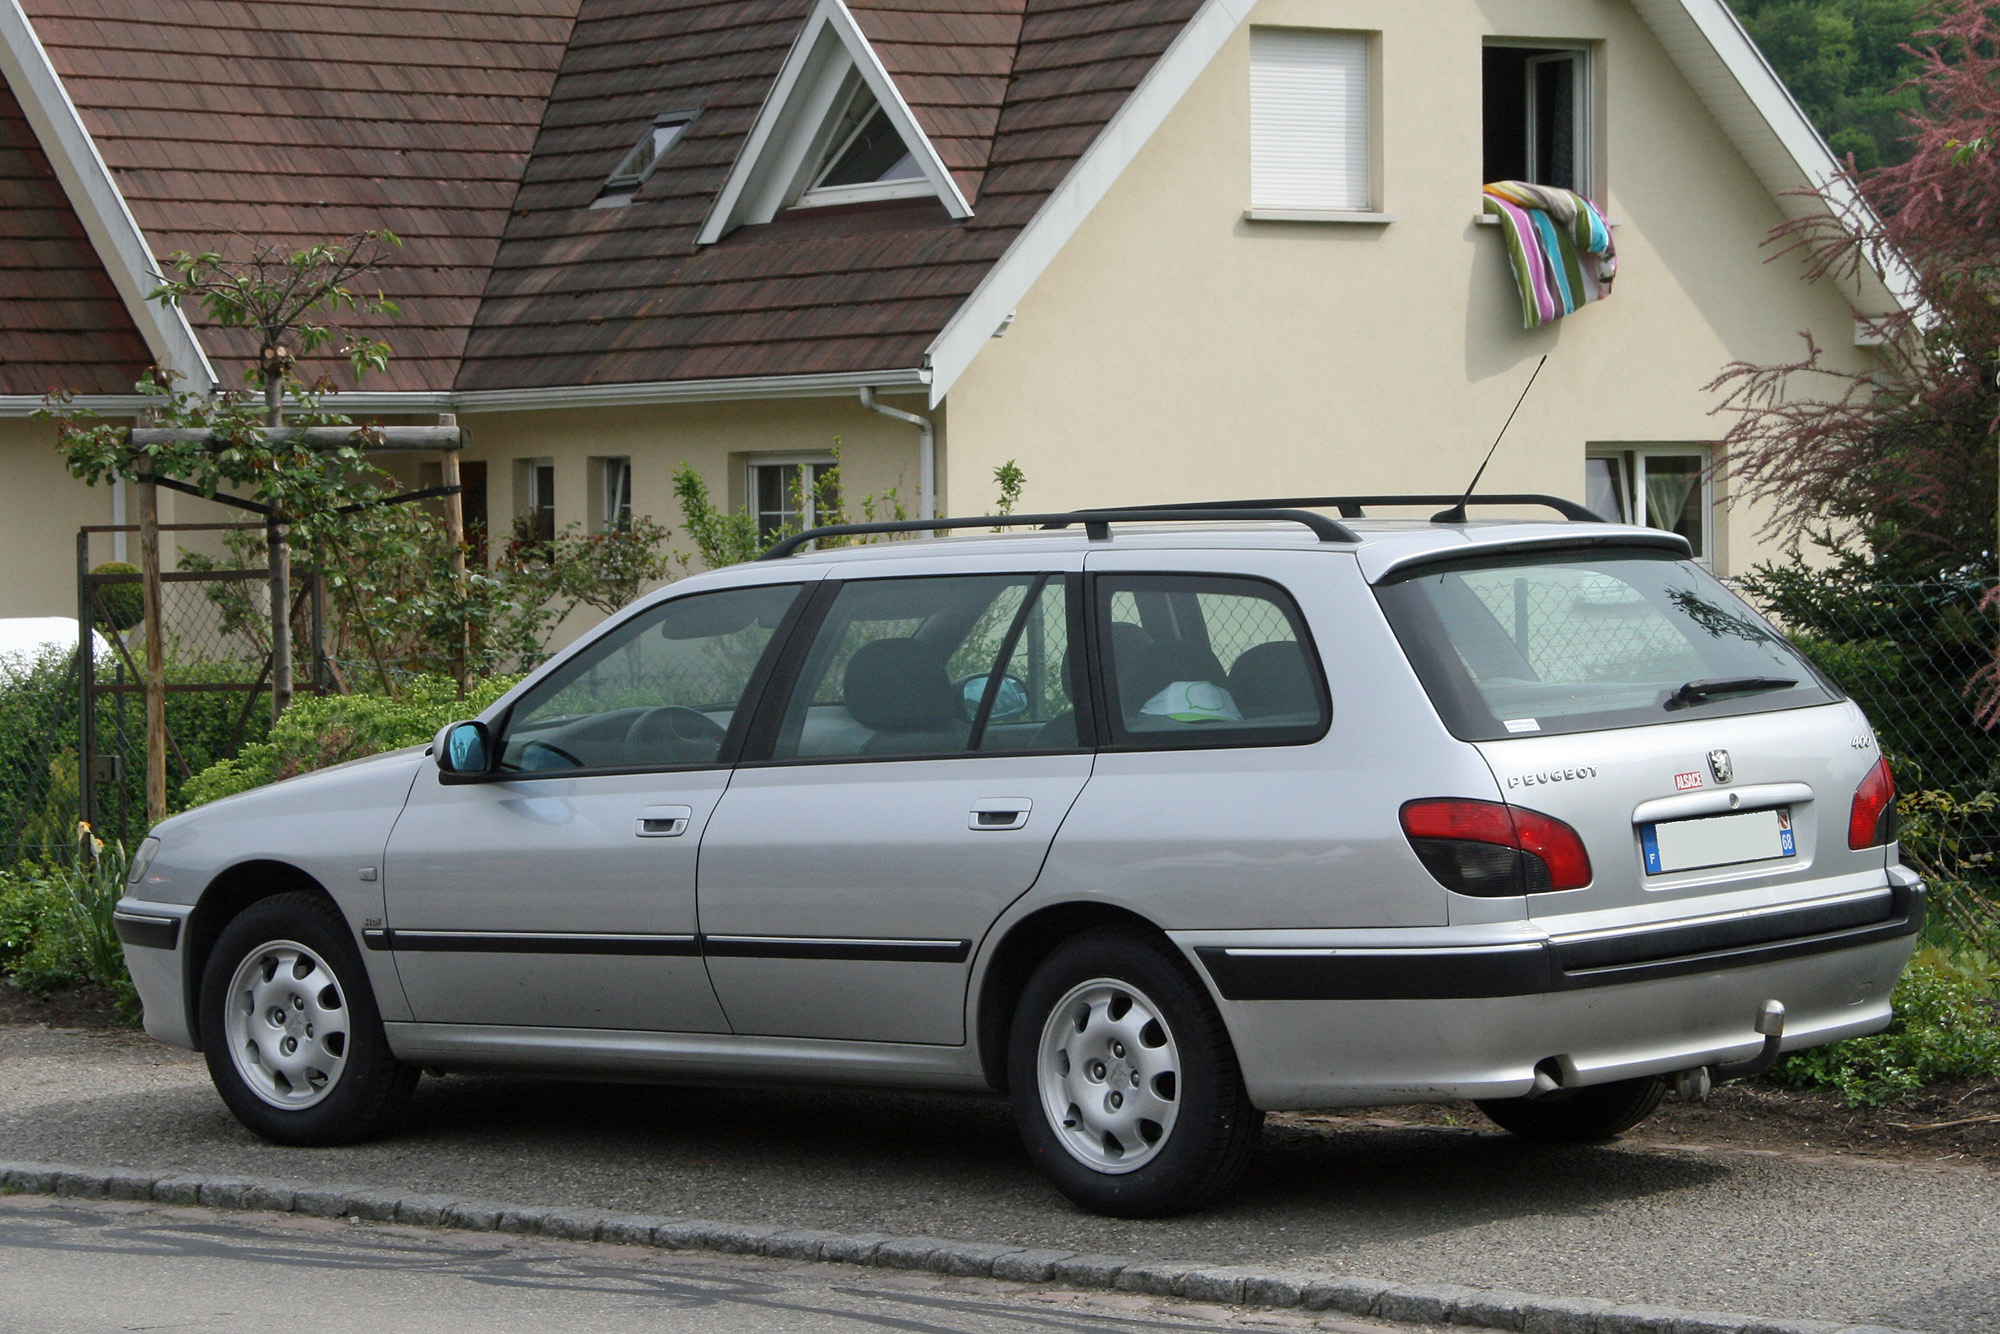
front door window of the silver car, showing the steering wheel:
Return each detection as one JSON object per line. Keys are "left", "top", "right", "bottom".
{"left": 500, "top": 584, "right": 798, "bottom": 774}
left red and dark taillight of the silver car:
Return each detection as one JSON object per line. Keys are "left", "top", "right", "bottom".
{"left": 1402, "top": 798, "right": 1590, "bottom": 898}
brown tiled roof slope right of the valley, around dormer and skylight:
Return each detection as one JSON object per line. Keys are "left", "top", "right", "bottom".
{"left": 458, "top": 0, "right": 1200, "bottom": 390}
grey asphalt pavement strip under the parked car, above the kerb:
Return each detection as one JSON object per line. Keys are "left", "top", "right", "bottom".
{"left": 0, "top": 1028, "right": 2000, "bottom": 1334}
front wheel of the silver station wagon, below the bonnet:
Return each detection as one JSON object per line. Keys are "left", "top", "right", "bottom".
{"left": 198, "top": 894, "right": 422, "bottom": 1146}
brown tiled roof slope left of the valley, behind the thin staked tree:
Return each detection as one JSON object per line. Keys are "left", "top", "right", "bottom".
{"left": 24, "top": 0, "right": 576, "bottom": 390}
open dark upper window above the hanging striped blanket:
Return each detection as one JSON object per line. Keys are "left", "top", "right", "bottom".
{"left": 1480, "top": 42, "right": 1598, "bottom": 198}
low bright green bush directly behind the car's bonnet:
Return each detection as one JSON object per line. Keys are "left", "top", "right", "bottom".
{"left": 180, "top": 676, "right": 520, "bottom": 808}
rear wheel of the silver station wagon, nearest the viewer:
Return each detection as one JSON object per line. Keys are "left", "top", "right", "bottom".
{"left": 1008, "top": 926, "right": 1264, "bottom": 1218}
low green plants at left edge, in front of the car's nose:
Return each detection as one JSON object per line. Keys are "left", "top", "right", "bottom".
{"left": 0, "top": 840, "right": 140, "bottom": 1020}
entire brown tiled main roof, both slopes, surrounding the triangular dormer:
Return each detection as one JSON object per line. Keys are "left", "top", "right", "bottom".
{"left": 11, "top": 0, "right": 1200, "bottom": 390}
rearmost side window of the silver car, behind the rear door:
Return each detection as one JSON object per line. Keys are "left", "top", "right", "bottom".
{"left": 1096, "top": 574, "right": 1332, "bottom": 750}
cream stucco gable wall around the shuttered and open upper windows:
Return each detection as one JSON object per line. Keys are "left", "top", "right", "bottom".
{"left": 948, "top": 0, "right": 1864, "bottom": 568}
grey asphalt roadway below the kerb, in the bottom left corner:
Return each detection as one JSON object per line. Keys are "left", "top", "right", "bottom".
{"left": 0, "top": 1202, "right": 1394, "bottom": 1334}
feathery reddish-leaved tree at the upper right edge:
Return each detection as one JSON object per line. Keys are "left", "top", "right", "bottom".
{"left": 1710, "top": 0, "right": 2000, "bottom": 578}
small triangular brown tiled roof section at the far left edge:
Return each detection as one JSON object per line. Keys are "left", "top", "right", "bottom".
{"left": 0, "top": 84, "right": 152, "bottom": 394}
